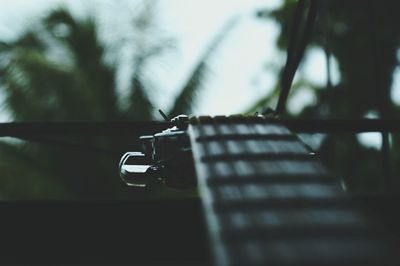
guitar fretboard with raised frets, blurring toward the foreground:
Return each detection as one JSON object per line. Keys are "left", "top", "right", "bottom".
{"left": 189, "top": 116, "right": 397, "bottom": 265}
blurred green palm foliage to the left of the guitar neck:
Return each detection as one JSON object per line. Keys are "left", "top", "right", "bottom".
{"left": 0, "top": 5, "right": 228, "bottom": 199}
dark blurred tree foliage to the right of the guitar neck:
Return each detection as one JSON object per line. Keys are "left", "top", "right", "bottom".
{"left": 255, "top": 0, "right": 400, "bottom": 193}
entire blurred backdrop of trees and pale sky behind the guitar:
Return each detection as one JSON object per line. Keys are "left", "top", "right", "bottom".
{"left": 0, "top": 0, "right": 400, "bottom": 200}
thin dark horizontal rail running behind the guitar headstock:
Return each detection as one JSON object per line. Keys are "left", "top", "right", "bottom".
{"left": 0, "top": 120, "right": 400, "bottom": 137}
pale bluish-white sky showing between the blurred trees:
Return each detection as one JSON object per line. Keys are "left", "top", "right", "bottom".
{"left": 0, "top": 0, "right": 338, "bottom": 115}
